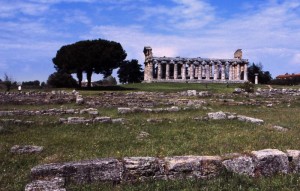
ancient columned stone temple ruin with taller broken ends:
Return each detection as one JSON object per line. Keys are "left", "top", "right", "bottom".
{"left": 144, "top": 47, "right": 249, "bottom": 83}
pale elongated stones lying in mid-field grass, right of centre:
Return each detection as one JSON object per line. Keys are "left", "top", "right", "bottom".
{"left": 207, "top": 111, "right": 264, "bottom": 125}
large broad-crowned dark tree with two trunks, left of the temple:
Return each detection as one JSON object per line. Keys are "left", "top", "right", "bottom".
{"left": 52, "top": 39, "right": 127, "bottom": 87}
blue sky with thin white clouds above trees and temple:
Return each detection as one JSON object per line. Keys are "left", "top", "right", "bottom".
{"left": 0, "top": 0, "right": 300, "bottom": 82}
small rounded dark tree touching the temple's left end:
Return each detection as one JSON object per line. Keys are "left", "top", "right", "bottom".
{"left": 118, "top": 60, "right": 143, "bottom": 83}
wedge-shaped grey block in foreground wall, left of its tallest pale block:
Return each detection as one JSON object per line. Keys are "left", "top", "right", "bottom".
{"left": 222, "top": 156, "right": 255, "bottom": 176}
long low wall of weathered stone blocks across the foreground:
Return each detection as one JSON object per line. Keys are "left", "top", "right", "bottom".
{"left": 25, "top": 149, "right": 300, "bottom": 191}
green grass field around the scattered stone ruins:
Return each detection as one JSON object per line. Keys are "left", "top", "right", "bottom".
{"left": 0, "top": 84, "right": 300, "bottom": 190}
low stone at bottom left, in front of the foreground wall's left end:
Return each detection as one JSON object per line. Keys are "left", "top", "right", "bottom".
{"left": 25, "top": 177, "right": 66, "bottom": 191}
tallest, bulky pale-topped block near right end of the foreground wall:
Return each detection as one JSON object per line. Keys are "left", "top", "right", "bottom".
{"left": 251, "top": 149, "right": 289, "bottom": 176}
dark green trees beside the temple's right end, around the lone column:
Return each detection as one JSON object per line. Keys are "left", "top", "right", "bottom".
{"left": 248, "top": 63, "right": 272, "bottom": 84}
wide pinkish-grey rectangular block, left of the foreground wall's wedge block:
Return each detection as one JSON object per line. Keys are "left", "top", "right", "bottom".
{"left": 164, "top": 156, "right": 222, "bottom": 179}
